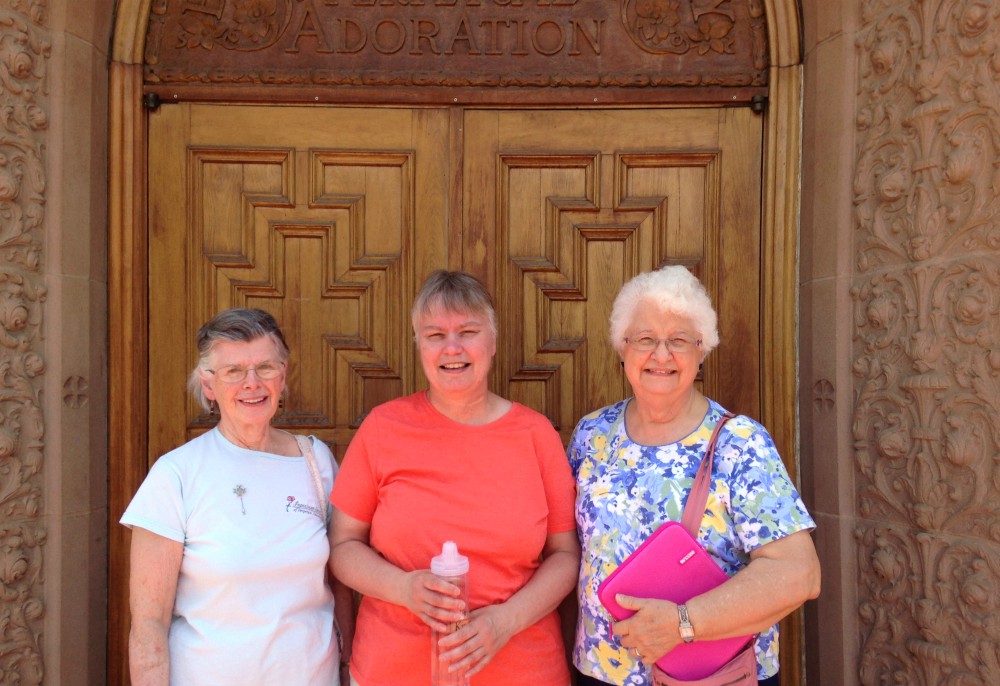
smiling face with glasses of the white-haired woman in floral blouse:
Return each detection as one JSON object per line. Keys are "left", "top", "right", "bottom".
{"left": 621, "top": 301, "right": 704, "bottom": 401}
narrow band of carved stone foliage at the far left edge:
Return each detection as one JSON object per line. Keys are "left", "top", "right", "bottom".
{"left": 0, "top": 0, "right": 50, "bottom": 686}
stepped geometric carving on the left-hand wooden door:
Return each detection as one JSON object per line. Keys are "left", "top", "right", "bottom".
{"left": 190, "top": 148, "right": 414, "bottom": 428}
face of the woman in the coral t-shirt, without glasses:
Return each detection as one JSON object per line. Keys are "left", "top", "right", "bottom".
{"left": 414, "top": 306, "right": 497, "bottom": 394}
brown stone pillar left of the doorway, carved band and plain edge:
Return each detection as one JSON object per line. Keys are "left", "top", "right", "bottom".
{"left": 0, "top": 0, "right": 113, "bottom": 686}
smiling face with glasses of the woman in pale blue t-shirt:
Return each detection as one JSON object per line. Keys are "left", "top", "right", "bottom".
{"left": 200, "top": 336, "right": 287, "bottom": 424}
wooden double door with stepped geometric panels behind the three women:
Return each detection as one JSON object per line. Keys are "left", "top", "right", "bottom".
{"left": 145, "top": 104, "right": 762, "bottom": 464}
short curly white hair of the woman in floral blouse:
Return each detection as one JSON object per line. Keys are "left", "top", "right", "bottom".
{"left": 610, "top": 265, "right": 719, "bottom": 356}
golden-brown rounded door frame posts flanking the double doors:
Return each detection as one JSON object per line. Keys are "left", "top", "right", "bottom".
{"left": 108, "top": 0, "right": 803, "bottom": 684}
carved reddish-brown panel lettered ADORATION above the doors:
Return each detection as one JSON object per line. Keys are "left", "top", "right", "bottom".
{"left": 145, "top": 0, "right": 768, "bottom": 89}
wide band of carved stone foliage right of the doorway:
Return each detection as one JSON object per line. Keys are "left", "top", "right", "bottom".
{"left": 852, "top": 0, "right": 1000, "bottom": 686}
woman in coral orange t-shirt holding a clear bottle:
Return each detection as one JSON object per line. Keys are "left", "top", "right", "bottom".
{"left": 331, "top": 271, "right": 580, "bottom": 686}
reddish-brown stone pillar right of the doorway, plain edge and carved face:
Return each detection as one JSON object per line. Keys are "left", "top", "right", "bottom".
{"left": 801, "top": 0, "right": 1000, "bottom": 685}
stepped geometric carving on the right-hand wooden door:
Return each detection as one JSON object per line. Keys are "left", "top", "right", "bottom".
{"left": 486, "top": 136, "right": 732, "bottom": 438}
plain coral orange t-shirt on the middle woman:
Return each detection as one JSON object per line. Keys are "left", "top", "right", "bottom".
{"left": 331, "top": 392, "right": 575, "bottom": 686}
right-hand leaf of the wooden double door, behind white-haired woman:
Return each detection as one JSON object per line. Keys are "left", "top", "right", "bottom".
{"left": 463, "top": 108, "right": 762, "bottom": 441}
